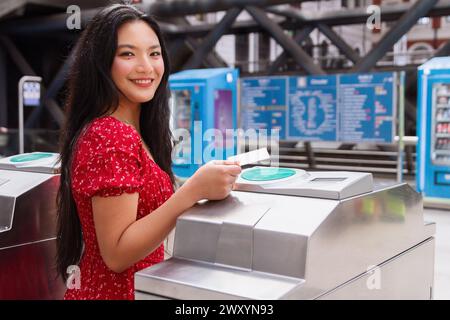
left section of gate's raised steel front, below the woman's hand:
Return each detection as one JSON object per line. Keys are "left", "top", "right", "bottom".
{"left": 174, "top": 195, "right": 270, "bottom": 269}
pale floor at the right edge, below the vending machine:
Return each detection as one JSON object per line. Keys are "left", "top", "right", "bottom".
{"left": 424, "top": 208, "right": 450, "bottom": 300}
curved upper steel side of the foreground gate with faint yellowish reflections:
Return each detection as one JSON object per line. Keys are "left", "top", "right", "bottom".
{"left": 298, "top": 184, "right": 435, "bottom": 298}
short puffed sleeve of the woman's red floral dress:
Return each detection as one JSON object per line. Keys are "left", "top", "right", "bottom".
{"left": 72, "top": 122, "right": 143, "bottom": 197}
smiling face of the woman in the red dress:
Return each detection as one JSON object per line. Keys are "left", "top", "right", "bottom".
{"left": 111, "top": 21, "right": 164, "bottom": 104}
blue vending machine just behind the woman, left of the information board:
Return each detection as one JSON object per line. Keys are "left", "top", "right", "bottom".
{"left": 169, "top": 68, "right": 239, "bottom": 179}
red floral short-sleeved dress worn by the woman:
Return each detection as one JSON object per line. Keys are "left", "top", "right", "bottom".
{"left": 64, "top": 116, "right": 173, "bottom": 300}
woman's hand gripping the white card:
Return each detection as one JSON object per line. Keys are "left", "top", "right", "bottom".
{"left": 182, "top": 160, "right": 241, "bottom": 205}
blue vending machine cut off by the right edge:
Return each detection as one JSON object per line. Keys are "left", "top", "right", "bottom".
{"left": 416, "top": 57, "right": 450, "bottom": 200}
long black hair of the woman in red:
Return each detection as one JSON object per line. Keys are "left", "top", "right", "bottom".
{"left": 56, "top": 4, "right": 174, "bottom": 280}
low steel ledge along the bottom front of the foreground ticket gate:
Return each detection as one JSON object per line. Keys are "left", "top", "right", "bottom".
{"left": 135, "top": 258, "right": 304, "bottom": 299}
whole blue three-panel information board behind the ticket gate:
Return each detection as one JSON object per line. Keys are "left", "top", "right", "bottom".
{"left": 240, "top": 72, "right": 398, "bottom": 143}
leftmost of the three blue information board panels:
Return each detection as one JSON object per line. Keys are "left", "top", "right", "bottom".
{"left": 240, "top": 77, "right": 287, "bottom": 139}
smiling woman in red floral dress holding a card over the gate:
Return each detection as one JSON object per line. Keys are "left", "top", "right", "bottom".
{"left": 57, "top": 5, "right": 241, "bottom": 299}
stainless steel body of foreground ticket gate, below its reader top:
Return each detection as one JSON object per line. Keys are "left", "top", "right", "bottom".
{"left": 135, "top": 171, "right": 435, "bottom": 299}
